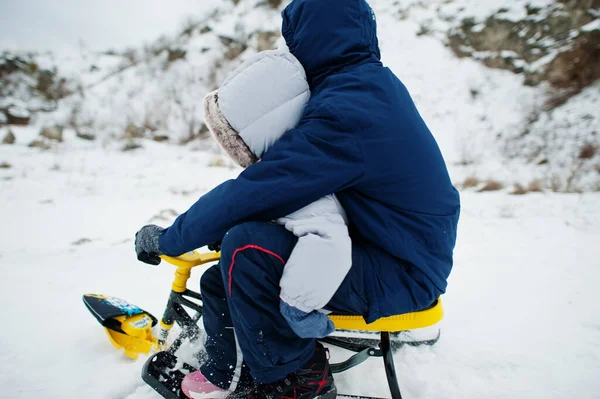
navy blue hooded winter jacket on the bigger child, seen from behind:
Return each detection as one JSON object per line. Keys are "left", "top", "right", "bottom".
{"left": 159, "top": 0, "right": 460, "bottom": 319}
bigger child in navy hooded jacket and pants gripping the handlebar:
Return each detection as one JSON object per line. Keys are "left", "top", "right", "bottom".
{"left": 136, "top": 0, "right": 460, "bottom": 399}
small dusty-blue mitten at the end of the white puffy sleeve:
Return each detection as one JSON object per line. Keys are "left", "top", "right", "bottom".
{"left": 279, "top": 301, "right": 335, "bottom": 338}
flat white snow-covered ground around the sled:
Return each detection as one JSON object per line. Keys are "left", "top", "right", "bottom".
{"left": 0, "top": 136, "right": 600, "bottom": 399}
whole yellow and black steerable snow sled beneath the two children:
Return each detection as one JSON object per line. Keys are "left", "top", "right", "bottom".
{"left": 84, "top": 251, "right": 443, "bottom": 399}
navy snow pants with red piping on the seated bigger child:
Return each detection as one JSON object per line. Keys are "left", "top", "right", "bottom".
{"left": 200, "top": 222, "right": 435, "bottom": 390}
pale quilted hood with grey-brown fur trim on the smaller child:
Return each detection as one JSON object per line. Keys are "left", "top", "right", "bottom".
{"left": 204, "top": 50, "right": 310, "bottom": 167}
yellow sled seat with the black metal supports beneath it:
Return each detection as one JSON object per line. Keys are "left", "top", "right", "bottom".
{"left": 321, "top": 299, "right": 444, "bottom": 399}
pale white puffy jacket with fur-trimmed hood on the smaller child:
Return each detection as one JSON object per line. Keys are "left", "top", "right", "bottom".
{"left": 204, "top": 50, "right": 352, "bottom": 327}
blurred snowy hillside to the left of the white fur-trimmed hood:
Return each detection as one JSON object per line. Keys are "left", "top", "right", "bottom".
{"left": 0, "top": 1, "right": 279, "bottom": 142}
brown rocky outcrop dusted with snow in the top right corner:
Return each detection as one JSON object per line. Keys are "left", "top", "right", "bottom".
{"left": 448, "top": 0, "right": 600, "bottom": 92}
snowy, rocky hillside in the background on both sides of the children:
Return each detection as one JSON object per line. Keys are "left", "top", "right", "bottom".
{"left": 0, "top": 0, "right": 600, "bottom": 192}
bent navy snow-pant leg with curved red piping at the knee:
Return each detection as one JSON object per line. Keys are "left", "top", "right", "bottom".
{"left": 220, "top": 222, "right": 318, "bottom": 383}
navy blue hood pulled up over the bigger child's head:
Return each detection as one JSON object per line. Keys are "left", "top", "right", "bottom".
{"left": 281, "top": 0, "right": 381, "bottom": 87}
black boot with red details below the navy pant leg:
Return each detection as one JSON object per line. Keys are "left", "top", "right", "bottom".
{"left": 247, "top": 342, "right": 337, "bottom": 399}
